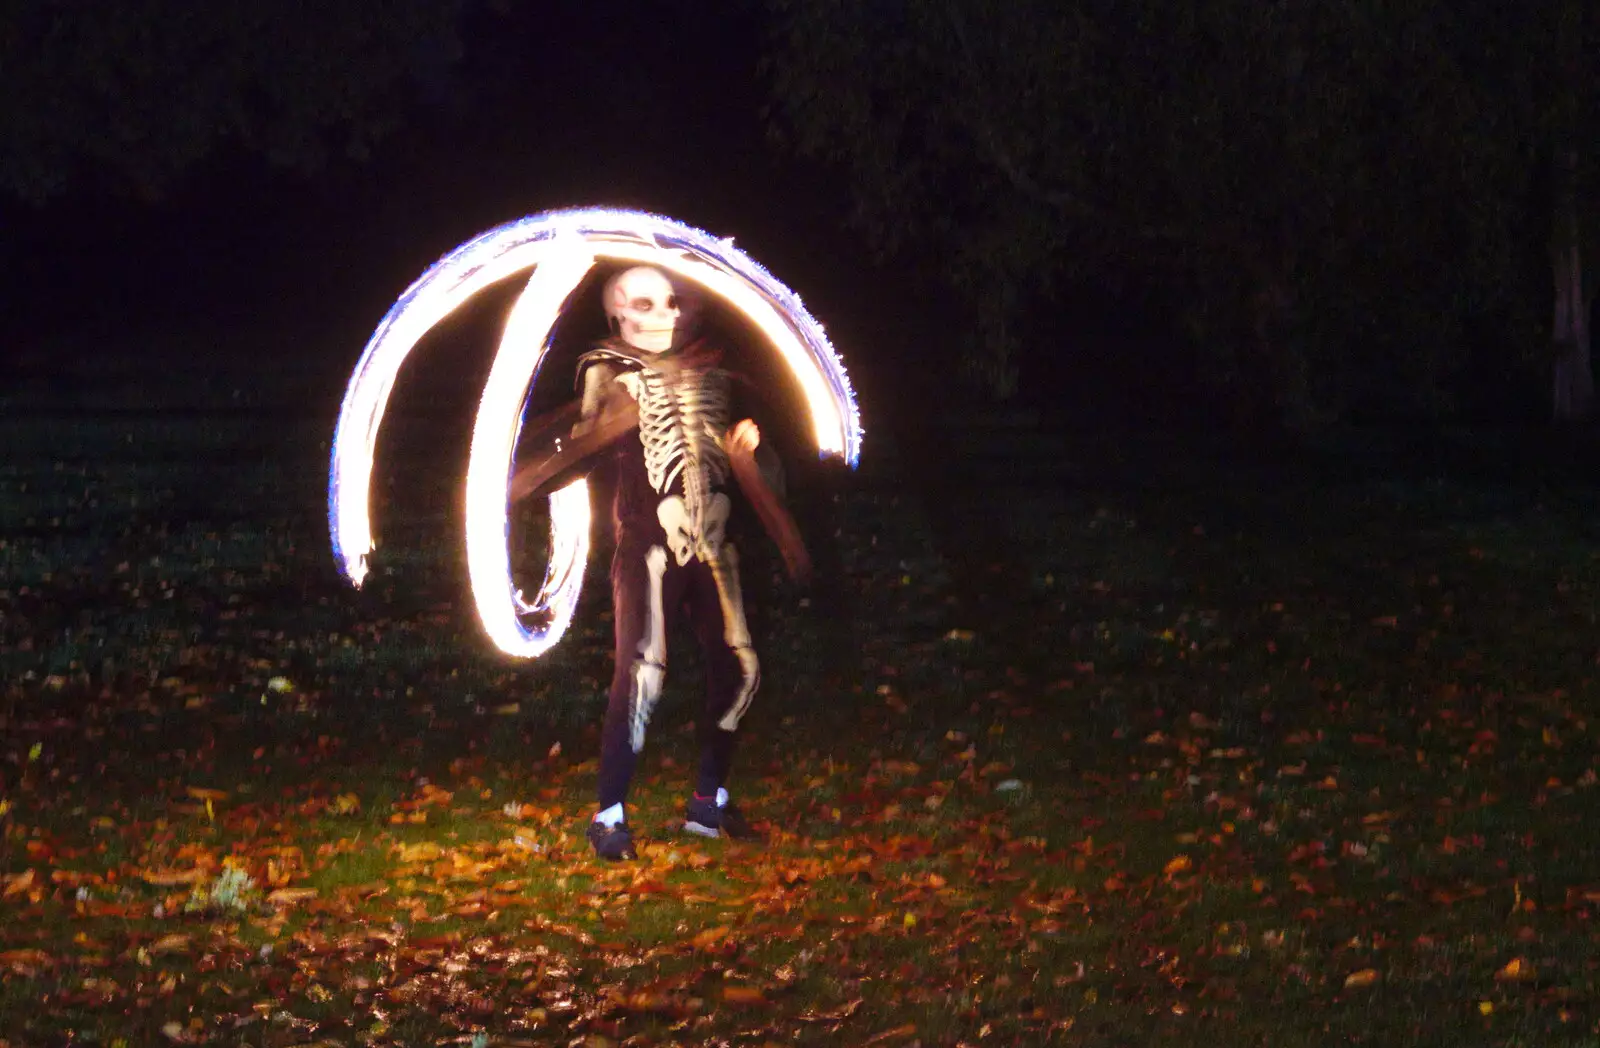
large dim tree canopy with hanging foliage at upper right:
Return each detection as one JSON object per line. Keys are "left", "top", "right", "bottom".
{"left": 770, "top": 0, "right": 1592, "bottom": 416}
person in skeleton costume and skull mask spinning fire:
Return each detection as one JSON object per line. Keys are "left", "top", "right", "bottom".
{"left": 531, "top": 266, "right": 810, "bottom": 859}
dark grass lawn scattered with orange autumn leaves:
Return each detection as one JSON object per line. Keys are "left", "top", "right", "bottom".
{"left": 0, "top": 400, "right": 1600, "bottom": 1046}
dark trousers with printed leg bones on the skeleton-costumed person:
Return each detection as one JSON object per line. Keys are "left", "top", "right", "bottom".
{"left": 600, "top": 541, "right": 744, "bottom": 810}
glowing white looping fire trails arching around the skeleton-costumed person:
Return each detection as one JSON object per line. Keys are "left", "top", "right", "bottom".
{"left": 328, "top": 208, "right": 861, "bottom": 656}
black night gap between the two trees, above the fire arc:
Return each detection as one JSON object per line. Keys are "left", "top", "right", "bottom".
{"left": 3, "top": 3, "right": 875, "bottom": 392}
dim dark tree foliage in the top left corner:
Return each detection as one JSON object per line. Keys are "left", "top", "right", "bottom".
{"left": 0, "top": 0, "right": 462, "bottom": 202}
